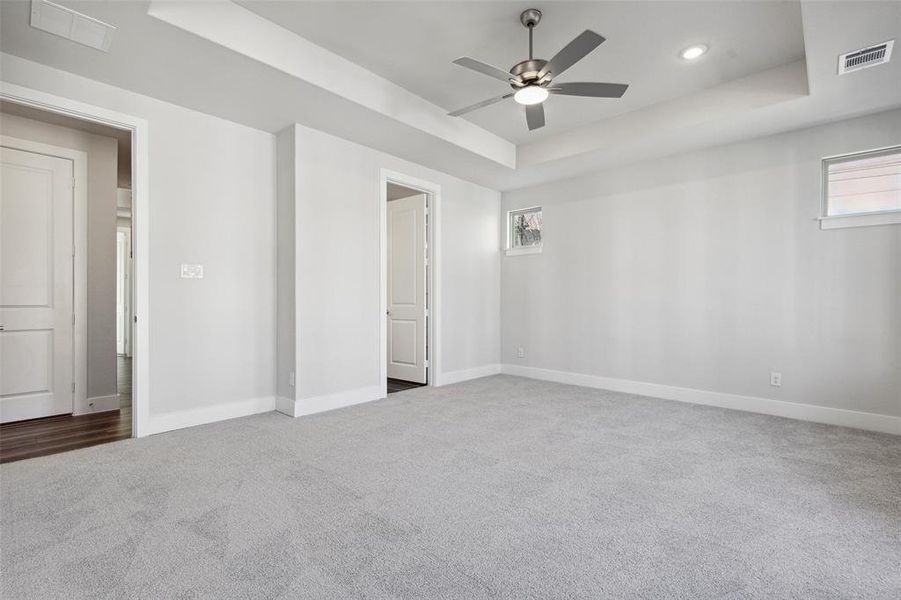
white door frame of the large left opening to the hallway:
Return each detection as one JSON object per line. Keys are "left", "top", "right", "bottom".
{"left": 0, "top": 81, "right": 150, "bottom": 437}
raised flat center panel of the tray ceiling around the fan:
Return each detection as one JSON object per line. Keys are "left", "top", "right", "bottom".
{"left": 239, "top": 0, "right": 804, "bottom": 144}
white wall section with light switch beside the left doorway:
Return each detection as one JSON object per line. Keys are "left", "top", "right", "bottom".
{"left": 0, "top": 55, "right": 276, "bottom": 430}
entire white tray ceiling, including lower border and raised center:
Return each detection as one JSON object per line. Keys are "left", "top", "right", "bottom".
{"left": 0, "top": 0, "right": 901, "bottom": 190}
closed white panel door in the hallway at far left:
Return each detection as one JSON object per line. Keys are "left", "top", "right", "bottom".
{"left": 0, "top": 148, "right": 74, "bottom": 423}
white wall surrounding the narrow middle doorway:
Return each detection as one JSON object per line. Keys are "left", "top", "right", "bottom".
{"left": 295, "top": 126, "right": 500, "bottom": 400}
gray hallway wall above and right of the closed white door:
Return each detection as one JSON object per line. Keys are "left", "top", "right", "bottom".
{"left": 0, "top": 114, "right": 117, "bottom": 404}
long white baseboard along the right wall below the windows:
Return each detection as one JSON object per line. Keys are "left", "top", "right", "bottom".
{"left": 502, "top": 364, "right": 901, "bottom": 435}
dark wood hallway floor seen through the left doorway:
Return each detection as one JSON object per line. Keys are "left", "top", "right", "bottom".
{"left": 0, "top": 356, "right": 131, "bottom": 463}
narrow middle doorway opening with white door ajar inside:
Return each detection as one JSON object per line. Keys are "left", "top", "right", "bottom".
{"left": 384, "top": 180, "right": 432, "bottom": 394}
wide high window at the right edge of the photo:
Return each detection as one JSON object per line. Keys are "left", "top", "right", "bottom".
{"left": 820, "top": 146, "right": 901, "bottom": 229}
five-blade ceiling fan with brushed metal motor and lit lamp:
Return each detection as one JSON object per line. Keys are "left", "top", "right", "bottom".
{"left": 447, "top": 8, "right": 629, "bottom": 131}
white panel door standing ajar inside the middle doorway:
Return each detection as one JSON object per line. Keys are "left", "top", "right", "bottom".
{"left": 388, "top": 194, "right": 427, "bottom": 383}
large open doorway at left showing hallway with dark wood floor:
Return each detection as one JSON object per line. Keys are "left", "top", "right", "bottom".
{"left": 0, "top": 100, "right": 134, "bottom": 462}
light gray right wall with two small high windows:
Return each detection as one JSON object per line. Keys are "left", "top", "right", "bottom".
{"left": 502, "top": 110, "right": 901, "bottom": 423}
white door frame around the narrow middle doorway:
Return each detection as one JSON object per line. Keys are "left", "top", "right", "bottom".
{"left": 379, "top": 169, "right": 441, "bottom": 397}
